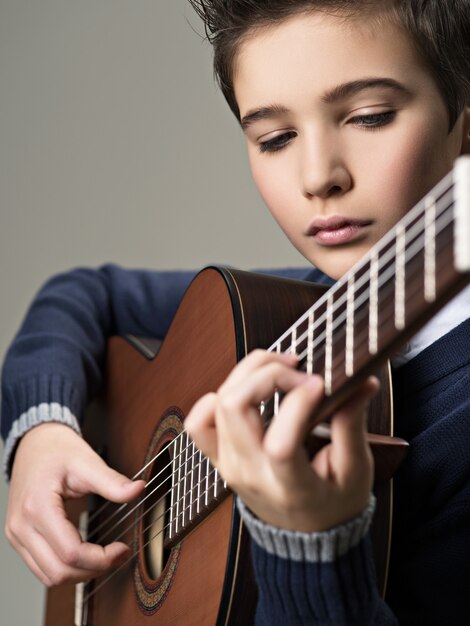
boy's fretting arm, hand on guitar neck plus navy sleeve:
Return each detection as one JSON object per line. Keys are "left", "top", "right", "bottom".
{"left": 186, "top": 352, "right": 396, "bottom": 626}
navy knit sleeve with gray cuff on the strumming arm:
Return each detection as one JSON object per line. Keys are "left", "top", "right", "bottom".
{"left": 1, "top": 265, "right": 194, "bottom": 477}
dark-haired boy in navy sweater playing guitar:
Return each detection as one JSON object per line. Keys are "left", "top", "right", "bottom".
{"left": 2, "top": 0, "right": 470, "bottom": 626}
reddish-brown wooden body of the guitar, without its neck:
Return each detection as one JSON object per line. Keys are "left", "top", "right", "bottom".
{"left": 45, "top": 268, "right": 391, "bottom": 626}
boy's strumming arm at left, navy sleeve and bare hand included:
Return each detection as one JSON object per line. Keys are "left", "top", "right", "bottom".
{"left": 2, "top": 266, "right": 192, "bottom": 585}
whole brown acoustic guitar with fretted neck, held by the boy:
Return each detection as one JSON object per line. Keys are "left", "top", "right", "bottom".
{"left": 45, "top": 158, "right": 470, "bottom": 626}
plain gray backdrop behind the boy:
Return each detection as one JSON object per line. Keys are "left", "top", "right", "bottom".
{"left": 0, "top": 0, "right": 304, "bottom": 626}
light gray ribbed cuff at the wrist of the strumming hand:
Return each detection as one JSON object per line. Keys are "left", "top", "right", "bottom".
{"left": 3, "top": 402, "right": 81, "bottom": 482}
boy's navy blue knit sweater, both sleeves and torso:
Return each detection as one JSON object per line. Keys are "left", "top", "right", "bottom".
{"left": 1, "top": 266, "right": 470, "bottom": 626}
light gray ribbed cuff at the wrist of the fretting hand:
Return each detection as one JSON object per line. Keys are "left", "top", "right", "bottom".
{"left": 237, "top": 494, "right": 375, "bottom": 563}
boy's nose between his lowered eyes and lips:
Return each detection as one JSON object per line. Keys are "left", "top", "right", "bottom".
{"left": 300, "top": 133, "right": 352, "bottom": 199}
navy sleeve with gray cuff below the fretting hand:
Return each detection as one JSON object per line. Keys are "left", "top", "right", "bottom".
{"left": 237, "top": 496, "right": 398, "bottom": 626}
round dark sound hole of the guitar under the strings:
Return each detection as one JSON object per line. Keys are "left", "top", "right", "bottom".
{"left": 142, "top": 446, "right": 171, "bottom": 580}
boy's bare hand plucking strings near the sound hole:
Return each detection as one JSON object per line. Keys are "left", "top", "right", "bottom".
{"left": 5, "top": 423, "right": 144, "bottom": 587}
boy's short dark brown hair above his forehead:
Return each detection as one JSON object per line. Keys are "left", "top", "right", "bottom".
{"left": 189, "top": 0, "right": 470, "bottom": 129}
